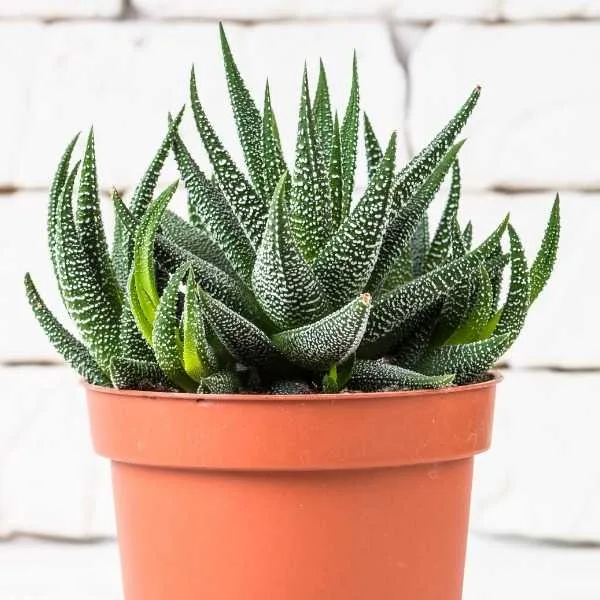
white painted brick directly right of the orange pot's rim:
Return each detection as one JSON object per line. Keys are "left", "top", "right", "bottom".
{"left": 471, "top": 370, "right": 600, "bottom": 543}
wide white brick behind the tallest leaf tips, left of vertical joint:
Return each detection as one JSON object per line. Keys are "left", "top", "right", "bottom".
{"left": 15, "top": 23, "right": 405, "bottom": 188}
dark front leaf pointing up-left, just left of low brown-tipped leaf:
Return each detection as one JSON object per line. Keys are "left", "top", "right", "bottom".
{"left": 200, "top": 291, "right": 281, "bottom": 368}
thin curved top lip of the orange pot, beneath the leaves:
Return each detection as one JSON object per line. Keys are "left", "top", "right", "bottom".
{"left": 81, "top": 369, "right": 504, "bottom": 403}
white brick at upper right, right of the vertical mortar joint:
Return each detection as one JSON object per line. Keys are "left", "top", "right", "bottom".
{"left": 408, "top": 23, "right": 600, "bottom": 190}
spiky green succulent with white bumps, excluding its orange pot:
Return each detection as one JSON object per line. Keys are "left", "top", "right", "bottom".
{"left": 25, "top": 28, "right": 560, "bottom": 393}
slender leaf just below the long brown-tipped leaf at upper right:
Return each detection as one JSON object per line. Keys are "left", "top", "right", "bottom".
{"left": 368, "top": 142, "right": 464, "bottom": 291}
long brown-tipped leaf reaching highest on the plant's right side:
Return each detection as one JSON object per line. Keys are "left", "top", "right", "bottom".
{"left": 395, "top": 86, "right": 481, "bottom": 207}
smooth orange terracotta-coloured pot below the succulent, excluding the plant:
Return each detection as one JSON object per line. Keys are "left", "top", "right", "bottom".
{"left": 87, "top": 376, "right": 499, "bottom": 600}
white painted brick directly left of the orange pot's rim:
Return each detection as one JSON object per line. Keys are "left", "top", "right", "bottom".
{"left": 0, "top": 367, "right": 114, "bottom": 539}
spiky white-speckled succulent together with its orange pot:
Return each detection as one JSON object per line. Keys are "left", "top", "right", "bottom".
{"left": 25, "top": 28, "right": 559, "bottom": 600}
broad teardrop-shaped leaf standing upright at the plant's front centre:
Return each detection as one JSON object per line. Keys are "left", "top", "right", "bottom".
{"left": 252, "top": 174, "right": 328, "bottom": 329}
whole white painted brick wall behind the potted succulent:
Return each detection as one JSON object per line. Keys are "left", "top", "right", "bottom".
{"left": 0, "top": 0, "right": 600, "bottom": 600}
